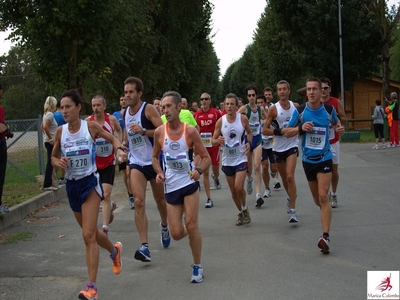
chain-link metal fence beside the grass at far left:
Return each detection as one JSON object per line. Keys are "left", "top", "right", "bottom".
{"left": 7, "top": 115, "right": 46, "bottom": 181}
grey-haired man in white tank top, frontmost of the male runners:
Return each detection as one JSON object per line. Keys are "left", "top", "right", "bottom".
{"left": 153, "top": 91, "right": 211, "bottom": 283}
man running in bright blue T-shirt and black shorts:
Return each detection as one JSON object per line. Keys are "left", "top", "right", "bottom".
{"left": 281, "top": 78, "right": 344, "bottom": 254}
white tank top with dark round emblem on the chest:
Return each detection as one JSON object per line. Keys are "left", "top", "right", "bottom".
{"left": 221, "top": 113, "right": 247, "bottom": 166}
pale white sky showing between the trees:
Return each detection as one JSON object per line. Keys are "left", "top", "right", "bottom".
{"left": 0, "top": 0, "right": 266, "bottom": 75}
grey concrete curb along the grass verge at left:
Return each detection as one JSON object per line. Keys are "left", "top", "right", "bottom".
{"left": 0, "top": 185, "right": 67, "bottom": 231}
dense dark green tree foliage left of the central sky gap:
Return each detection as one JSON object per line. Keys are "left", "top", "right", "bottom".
{"left": 0, "top": 0, "right": 219, "bottom": 110}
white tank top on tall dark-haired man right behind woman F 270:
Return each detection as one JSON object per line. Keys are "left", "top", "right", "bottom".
{"left": 125, "top": 102, "right": 153, "bottom": 166}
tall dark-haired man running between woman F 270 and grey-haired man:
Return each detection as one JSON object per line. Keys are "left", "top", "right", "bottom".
{"left": 124, "top": 77, "right": 171, "bottom": 262}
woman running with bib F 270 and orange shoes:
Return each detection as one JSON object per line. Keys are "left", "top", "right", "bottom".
{"left": 51, "top": 90, "right": 124, "bottom": 299}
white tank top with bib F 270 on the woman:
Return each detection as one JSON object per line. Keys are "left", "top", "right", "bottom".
{"left": 61, "top": 120, "right": 97, "bottom": 180}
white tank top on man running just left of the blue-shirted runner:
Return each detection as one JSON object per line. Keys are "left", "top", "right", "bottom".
{"left": 272, "top": 100, "right": 299, "bottom": 152}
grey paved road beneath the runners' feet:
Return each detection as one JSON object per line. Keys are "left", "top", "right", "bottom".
{"left": 0, "top": 144, "right": 400, "bottom": 300}
